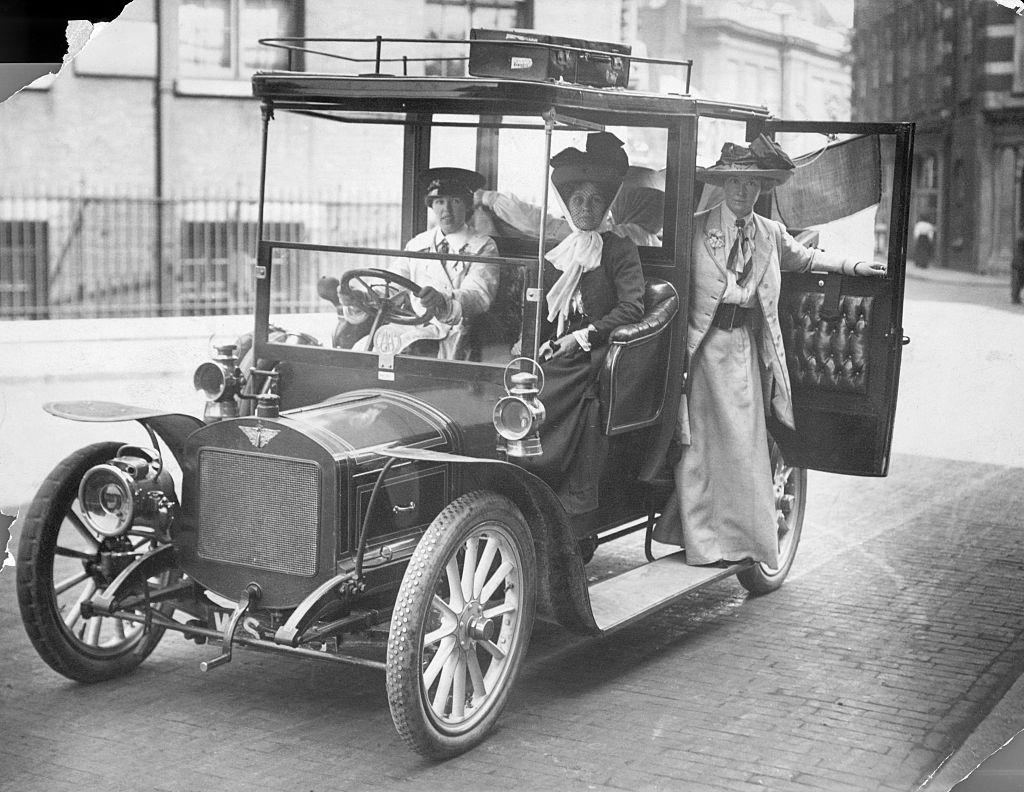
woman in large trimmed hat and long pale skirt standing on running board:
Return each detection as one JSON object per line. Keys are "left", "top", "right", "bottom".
{"left": 654, "top": 135, "right": 886, "bottom": 568}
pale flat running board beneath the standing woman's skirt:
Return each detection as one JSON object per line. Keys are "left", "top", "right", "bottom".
{"left": 590, "top": 551, "right": 752, "bottom": 632}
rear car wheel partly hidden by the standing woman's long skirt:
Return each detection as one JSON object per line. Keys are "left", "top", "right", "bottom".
{"left": 736, "top": 436, "right": 807, "bottom": 595}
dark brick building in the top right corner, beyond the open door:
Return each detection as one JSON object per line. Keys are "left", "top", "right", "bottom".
{"left": 853, "top": 0, "right": 1024, "bottom": 274}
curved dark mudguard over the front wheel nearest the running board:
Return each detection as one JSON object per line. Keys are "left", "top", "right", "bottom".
{"left": 376, "top": 446, "right": 601, "bottom": 635}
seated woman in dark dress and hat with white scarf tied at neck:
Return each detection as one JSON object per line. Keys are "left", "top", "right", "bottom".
{"left": 523, "top": 132, "right": 644, "bottom": 514}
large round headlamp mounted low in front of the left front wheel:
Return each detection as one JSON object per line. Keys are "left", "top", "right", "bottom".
{"left": 78, "top": 446, "right": 173, "bottom": 538}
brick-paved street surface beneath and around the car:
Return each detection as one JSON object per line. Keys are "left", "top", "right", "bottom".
{"left": 0, "top": 267, "right": 1024, "bottom": 792}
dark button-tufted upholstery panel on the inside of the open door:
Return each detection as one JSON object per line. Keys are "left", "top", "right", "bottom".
{"left": 779, "top": 292, "right": 873, "bottom": 393}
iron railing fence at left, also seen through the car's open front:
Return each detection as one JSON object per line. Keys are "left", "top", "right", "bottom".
{"left": 0, "top": 188, "right": 401, "bottom": 320}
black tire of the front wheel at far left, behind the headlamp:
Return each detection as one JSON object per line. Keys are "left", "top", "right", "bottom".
{"left": 17, "top": 443, "right": 167, "bottom": 682}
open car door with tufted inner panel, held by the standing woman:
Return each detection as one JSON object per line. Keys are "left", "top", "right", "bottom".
{"left": 749, "top": 120, "right": 913, "bottom": 475}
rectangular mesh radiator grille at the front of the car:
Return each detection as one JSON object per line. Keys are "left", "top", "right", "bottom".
{"left": 197, "top": 449, "right": 321, "bottom": 576}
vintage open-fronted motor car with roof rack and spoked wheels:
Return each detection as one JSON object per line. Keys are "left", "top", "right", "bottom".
{"left": 17, "top": 32, "right": 913, "bottom": 757}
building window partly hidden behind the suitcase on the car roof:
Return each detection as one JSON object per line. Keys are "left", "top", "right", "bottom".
{"left": 424, "top": 0, "right": 534, "bottom": 77}
